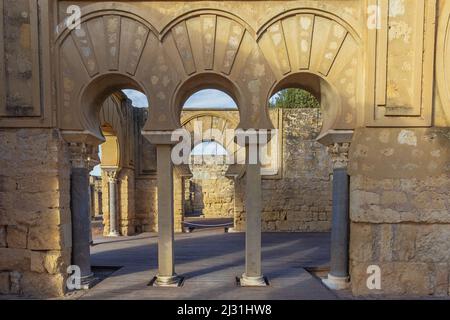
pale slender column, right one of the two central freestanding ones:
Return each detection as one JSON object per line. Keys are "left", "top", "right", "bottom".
{"left": 241, "top": 142, "right": 266, "bottom": 286}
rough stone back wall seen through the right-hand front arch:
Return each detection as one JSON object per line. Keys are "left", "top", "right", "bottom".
{"left": 235, "top": 109, "right": 332, "bottom": 232}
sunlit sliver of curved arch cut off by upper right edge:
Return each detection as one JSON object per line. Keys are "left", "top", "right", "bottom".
{"left": 436, "top": 2, "right": 450, "bottom": 122}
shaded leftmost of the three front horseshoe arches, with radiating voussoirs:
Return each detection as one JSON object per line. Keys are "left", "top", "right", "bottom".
{"left": 56, "top": 3, "right": 163, "bottom": 139}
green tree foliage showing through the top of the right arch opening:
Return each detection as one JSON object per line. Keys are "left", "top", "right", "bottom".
{"left": 270, "top": 88, "right": 320, "bottom": 109}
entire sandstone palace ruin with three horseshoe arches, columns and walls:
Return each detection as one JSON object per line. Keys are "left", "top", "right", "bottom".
{"left": 0, "top": 0, "right": 450, "bottom": 299}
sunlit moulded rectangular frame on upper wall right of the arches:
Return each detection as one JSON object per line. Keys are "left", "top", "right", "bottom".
{"left": 365, "top": 0, "right": 436, "bottom": 127}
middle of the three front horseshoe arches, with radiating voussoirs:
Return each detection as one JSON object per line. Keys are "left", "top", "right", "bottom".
{"left": 146, "top": 10, "right": 273, "bottom": 130}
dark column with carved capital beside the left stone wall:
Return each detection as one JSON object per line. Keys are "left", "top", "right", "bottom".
{"left": 69, "top": 142, "right": 94, "bottom": 289}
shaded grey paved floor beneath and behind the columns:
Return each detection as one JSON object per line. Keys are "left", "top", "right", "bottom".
{"left": 77, "top": 229, "right": 337, "bottom": 300}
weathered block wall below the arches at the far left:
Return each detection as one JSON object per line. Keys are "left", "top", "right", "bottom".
{"left": 0, "top": 129, "right": 72, "bottom": 297}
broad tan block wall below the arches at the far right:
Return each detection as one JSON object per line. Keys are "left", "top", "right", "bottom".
{"left": 350, "top": 128, "right": 450, "bottom": 296}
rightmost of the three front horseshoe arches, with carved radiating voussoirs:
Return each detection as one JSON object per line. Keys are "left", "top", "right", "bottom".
{"left": 258, "top": 8, "right": 364, "bottom": 134}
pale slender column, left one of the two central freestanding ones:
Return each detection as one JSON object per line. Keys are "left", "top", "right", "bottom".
{"left": 156, "top": 144, "right": 179, "bottom": 286}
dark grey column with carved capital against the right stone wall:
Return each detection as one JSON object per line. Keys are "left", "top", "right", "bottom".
{"left": 323, "top": 143, "right": 350, "bottom": 290}
